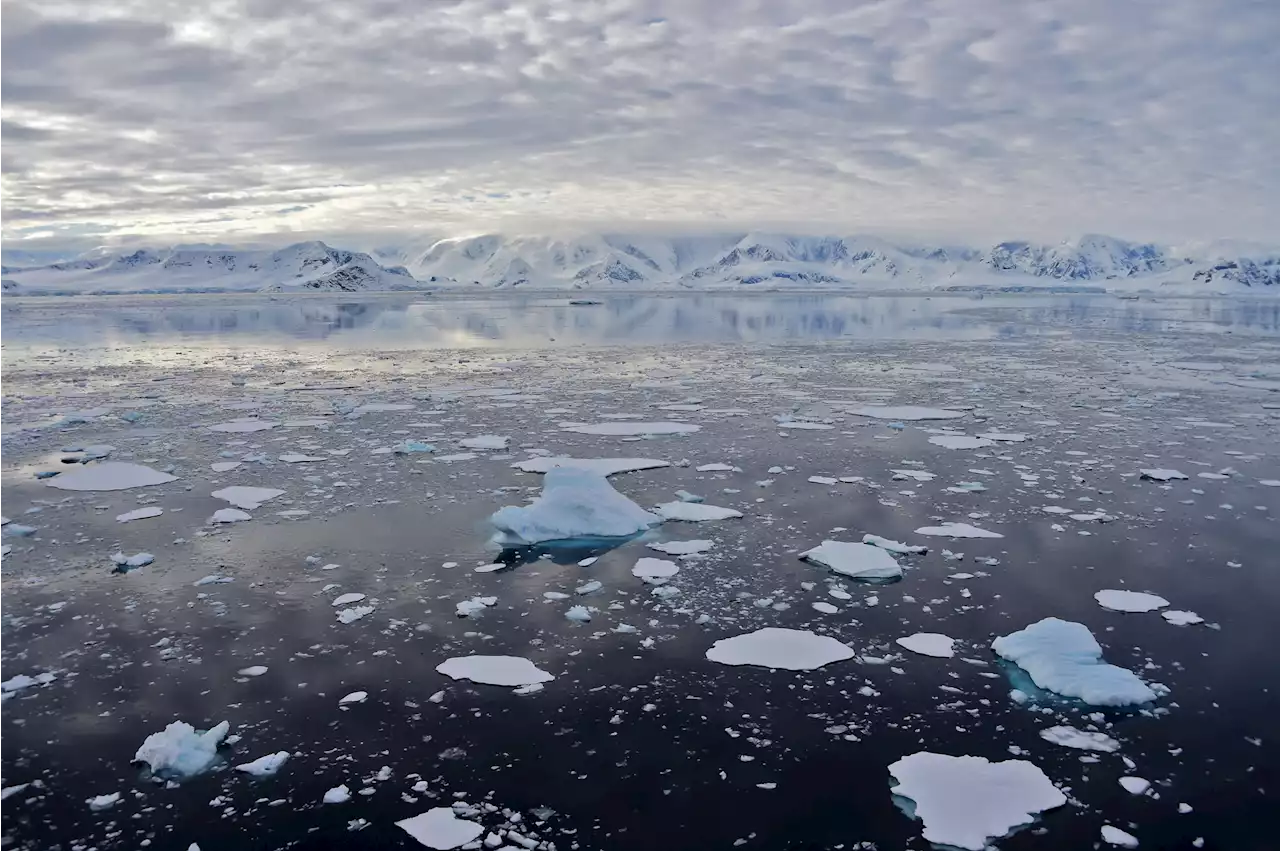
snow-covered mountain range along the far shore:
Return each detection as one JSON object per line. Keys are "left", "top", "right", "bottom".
{"left": 0, "top": 233, "right": 1280, "bottom": 294}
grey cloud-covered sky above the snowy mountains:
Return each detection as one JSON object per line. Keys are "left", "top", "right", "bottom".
{"left": 0, "top": 0, "right": 1280, "bottom": 242}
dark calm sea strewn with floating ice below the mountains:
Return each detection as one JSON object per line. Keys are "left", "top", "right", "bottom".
{"left": 0, "top": 293, "right": 1280, "bottom": 851}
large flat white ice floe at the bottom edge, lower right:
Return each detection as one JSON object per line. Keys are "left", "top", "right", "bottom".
{"left": 888, "top": 751, "right": 1066, "bottom": 851}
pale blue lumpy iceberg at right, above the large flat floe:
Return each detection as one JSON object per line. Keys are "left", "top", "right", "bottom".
{"left": 991, "top": 618, "right": 1156, "bottom": 706}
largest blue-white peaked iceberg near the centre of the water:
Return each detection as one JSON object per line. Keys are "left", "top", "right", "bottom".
{"left": 489, "top": 467, "right": 662, "bottom": 546}
